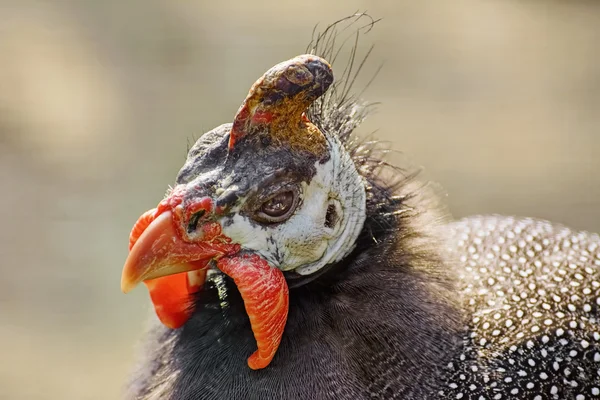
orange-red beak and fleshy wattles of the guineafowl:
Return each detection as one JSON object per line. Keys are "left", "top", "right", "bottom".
{"left": 121, "top": 206, "right": 289, "bottom": 369}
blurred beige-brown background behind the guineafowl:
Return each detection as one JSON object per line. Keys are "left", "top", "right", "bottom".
{"left": 0, "top": 0, "right": 600, "bottom": 400}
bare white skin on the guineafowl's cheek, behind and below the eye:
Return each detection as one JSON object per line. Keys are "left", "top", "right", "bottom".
{"left": 216, "top": 135, "right": 366, "bottom": 275}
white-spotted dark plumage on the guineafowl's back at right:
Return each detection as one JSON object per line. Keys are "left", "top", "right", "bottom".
{"left": 440, "top": 217, "right": 600, "bottom": 400}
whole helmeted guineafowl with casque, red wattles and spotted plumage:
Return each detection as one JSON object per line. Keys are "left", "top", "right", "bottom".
{"left": 122, "top": 17, "right": 600, "bottom": 400}
